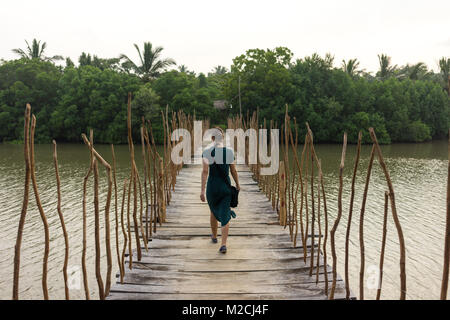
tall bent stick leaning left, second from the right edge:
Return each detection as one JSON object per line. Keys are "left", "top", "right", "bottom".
{"left": 369, "top": 128, "right": 406, "bottom": 300}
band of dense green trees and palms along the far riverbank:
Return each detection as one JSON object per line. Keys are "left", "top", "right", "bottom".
{"left": 0, "top": 40, "right": 450, "bottom": 144}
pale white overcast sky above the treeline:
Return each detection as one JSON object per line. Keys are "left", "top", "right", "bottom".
{"left": 0, "top": 0, "right": 450, "bottom": 73}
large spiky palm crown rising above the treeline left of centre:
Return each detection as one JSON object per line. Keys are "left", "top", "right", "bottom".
{"left": 120, "top": 42, "right": 176, "bottom": 81}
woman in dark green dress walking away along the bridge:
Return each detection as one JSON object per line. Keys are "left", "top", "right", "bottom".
{"left": 200, "top": 128, "right": 240, "bottom": 253}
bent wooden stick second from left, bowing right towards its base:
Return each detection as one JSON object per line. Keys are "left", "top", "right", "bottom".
{"left": 30, "top": 115, "right": 50, "bottom": 300}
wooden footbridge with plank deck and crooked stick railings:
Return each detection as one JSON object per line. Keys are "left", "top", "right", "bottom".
{"left": 13, "top": 102, "right": 414, "bottom": 300}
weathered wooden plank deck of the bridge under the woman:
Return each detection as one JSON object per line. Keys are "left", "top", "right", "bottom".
{"left": 108, "top": 165, "right": 345, "bottom": 300}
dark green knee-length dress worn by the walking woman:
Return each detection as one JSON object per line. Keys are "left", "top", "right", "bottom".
{"left": 202, "top": 147, "right": 236, "bottom": 227}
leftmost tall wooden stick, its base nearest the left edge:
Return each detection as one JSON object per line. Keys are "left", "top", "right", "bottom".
{"left": 12, "top": 104, "right": 31, "bottom": 300}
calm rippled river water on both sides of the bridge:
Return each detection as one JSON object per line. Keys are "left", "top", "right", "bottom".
{"left": 0, "top": 141, "right": 447, "bottom": 299}
